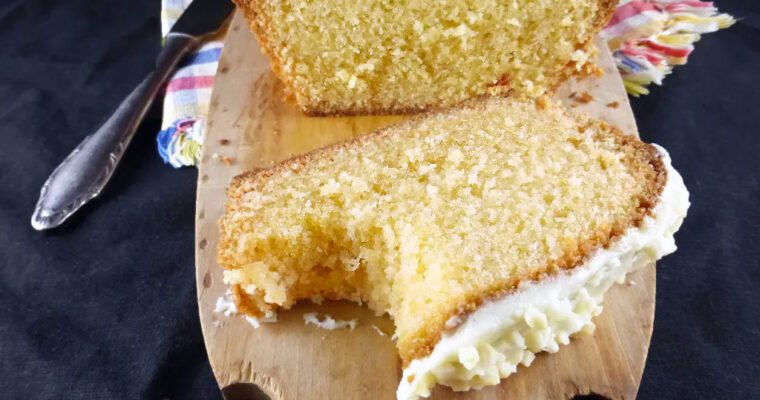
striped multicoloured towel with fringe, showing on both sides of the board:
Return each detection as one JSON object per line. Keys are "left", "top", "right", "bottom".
{"left": 158, "top": 0, "right": 734, "bottom": 168}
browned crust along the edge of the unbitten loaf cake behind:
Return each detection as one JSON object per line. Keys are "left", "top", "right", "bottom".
{"left": 232, "top": 0, "right": 618, "bottom": 117}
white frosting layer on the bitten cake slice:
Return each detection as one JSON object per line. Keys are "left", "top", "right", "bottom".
{"left": 396, "top": 145, "right": 689, "bottom": 400}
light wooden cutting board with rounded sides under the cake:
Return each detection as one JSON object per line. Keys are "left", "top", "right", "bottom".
{"left": 195, "top": 13, "right": 655, "bottom": 400}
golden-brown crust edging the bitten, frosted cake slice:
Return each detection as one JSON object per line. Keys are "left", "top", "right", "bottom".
{"left": 218, "top": 95, "right": 667, "bottom": 367}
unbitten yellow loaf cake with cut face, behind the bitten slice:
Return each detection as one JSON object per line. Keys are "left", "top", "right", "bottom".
{"left": 234, "top": 0, "right": 617, "bottom": 115}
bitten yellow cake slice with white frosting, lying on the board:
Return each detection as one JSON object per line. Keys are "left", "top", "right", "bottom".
{"left": 218, "top": 97, "right": 689, "bottom": 399}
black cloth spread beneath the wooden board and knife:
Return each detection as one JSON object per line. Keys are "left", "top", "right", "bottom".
{"left": 0, "top": 0, "right": 760, "bottom": 399}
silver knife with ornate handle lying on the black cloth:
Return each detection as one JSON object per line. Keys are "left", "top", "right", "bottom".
{"left": 32, "top": 0, "right": 234, "bottom": 230}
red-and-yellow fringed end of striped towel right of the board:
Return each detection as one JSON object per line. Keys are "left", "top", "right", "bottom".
{"left": 601, "top": 0, "right": 735, "bottom": 96}
